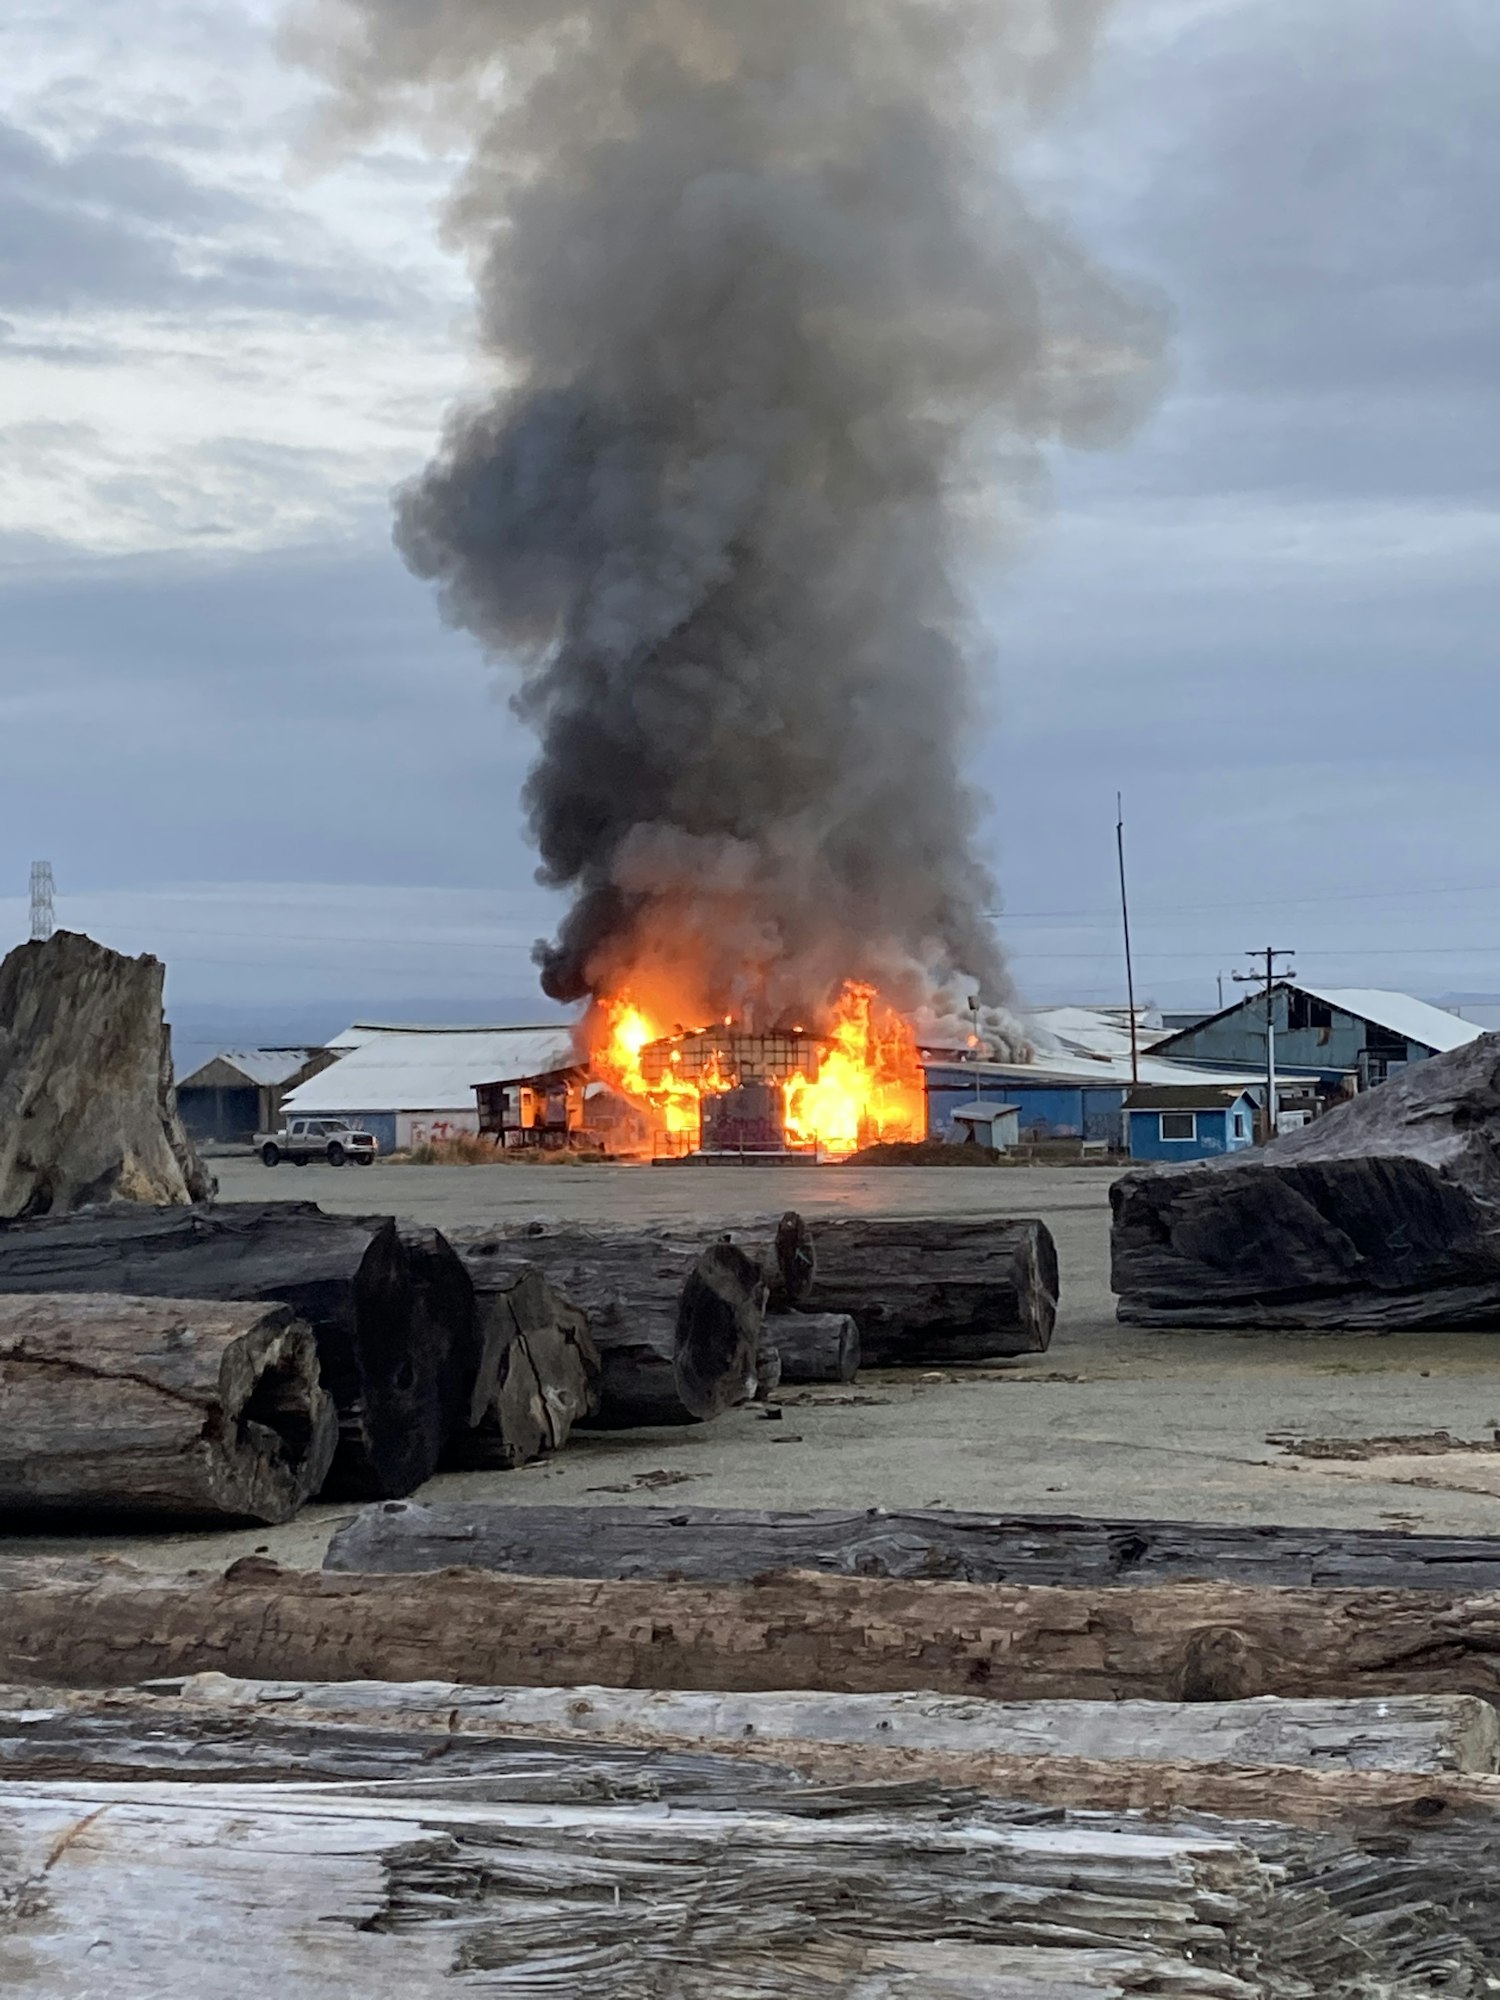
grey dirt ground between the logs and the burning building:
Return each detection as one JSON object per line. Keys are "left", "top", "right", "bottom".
{"left": 10, "top": 1160, "right": 1500, "bottom": 1564}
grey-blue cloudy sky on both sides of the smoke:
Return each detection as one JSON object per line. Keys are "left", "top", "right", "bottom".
{"left": 0, "top": 0, "right": 1500, "bottom": 1016}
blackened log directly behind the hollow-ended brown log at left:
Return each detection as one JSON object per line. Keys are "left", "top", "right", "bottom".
{"left": 0, "top": 1202, "right": 480, "bottom": 1500}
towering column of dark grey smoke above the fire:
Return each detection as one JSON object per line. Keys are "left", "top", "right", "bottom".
{"left": 296, "top": 0, "right": 1160, "bottom": 1042}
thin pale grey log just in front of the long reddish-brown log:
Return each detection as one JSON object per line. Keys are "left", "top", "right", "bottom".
{"left": 129, "top": 1674, "right": 1500, "bottom": 1776}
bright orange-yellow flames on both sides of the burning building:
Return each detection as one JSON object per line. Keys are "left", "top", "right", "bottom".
{"left": 592, "top": 984, "right": 926, "bottom": 1158}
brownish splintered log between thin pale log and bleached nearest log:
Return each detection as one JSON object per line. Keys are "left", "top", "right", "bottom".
{"left": 0, "top": 1674, "right": 1500, "bottom": 2000}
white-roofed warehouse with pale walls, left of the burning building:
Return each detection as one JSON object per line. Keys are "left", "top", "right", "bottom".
{"left": 284, "top": 1024, "right": 574, "bottom": 1154}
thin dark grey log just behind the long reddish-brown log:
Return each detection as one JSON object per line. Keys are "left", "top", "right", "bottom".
{"left": 326, "top": 1500, "right": 1500, "bottom": 1594}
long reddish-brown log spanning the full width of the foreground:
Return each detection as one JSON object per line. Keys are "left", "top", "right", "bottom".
{"left": 14, "top": 1558, "right": 1500, "bottom": 1702}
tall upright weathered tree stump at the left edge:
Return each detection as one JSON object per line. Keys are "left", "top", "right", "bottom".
{"left": 0, "top": 930, "right": 214, "bottom": 1220}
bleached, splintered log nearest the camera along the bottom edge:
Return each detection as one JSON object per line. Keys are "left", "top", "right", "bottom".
{"left": 0, "top": 1780, "right": 1376, "bottom": 2000}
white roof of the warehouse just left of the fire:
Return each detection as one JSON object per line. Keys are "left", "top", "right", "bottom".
{"left": 284, "top": 1022, "right": 574, "bottom": 1116}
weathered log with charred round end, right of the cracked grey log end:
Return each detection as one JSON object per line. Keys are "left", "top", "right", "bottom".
{"left": 462, "top": 1230, "right": 766, "bottom": 1430}
